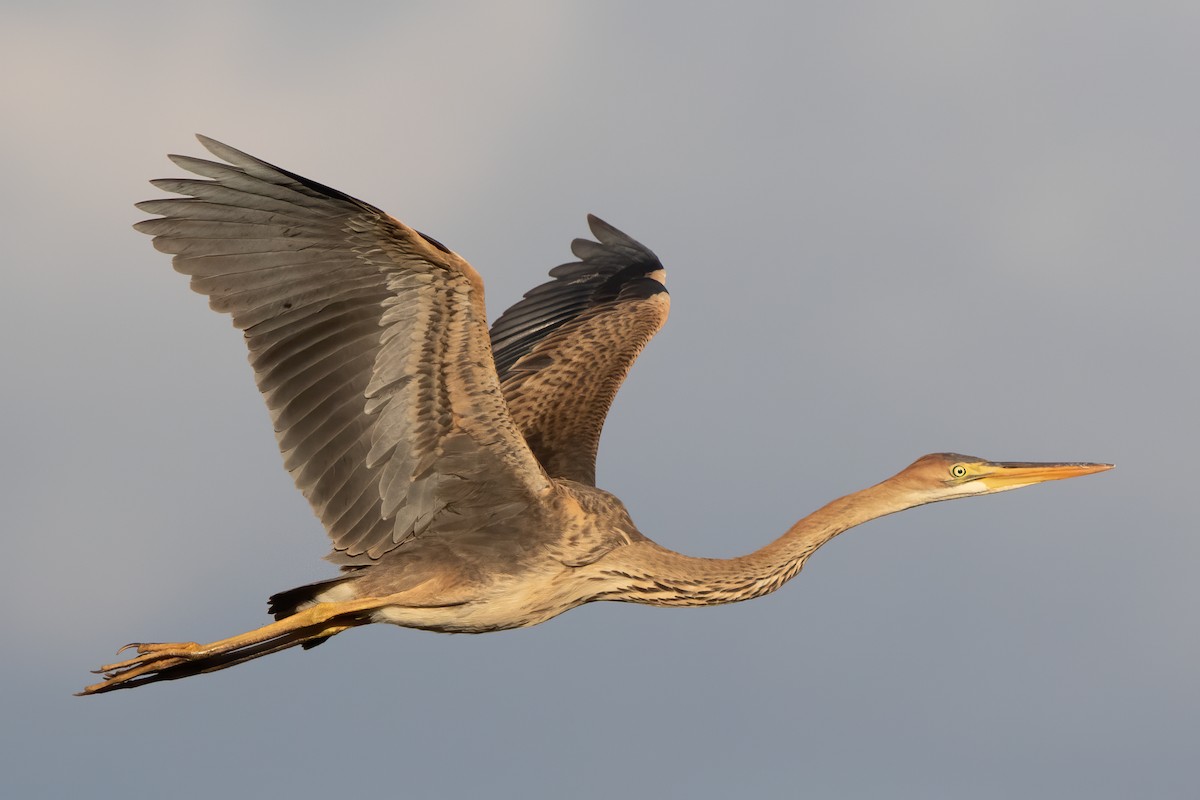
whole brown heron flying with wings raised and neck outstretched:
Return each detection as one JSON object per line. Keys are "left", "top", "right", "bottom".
{"left": 80, "top": 136, "right": 1111, "bottom": 694}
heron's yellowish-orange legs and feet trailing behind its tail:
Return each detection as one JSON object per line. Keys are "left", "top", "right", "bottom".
{"left": 79, "top": 597, "right": 383, "bottom": 694}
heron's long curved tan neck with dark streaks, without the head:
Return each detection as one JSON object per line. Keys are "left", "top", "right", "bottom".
{"left": 593, "top": 481, "right": 929, "bottom": 606}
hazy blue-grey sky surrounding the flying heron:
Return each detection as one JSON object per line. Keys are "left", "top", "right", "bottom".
{"left": 0, "top": 0, "right": 1200, "bottom": 800}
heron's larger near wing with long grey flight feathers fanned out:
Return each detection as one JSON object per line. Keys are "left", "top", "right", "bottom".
{"left": 136, "top": 137, "right": 550, "bottom": 564}
